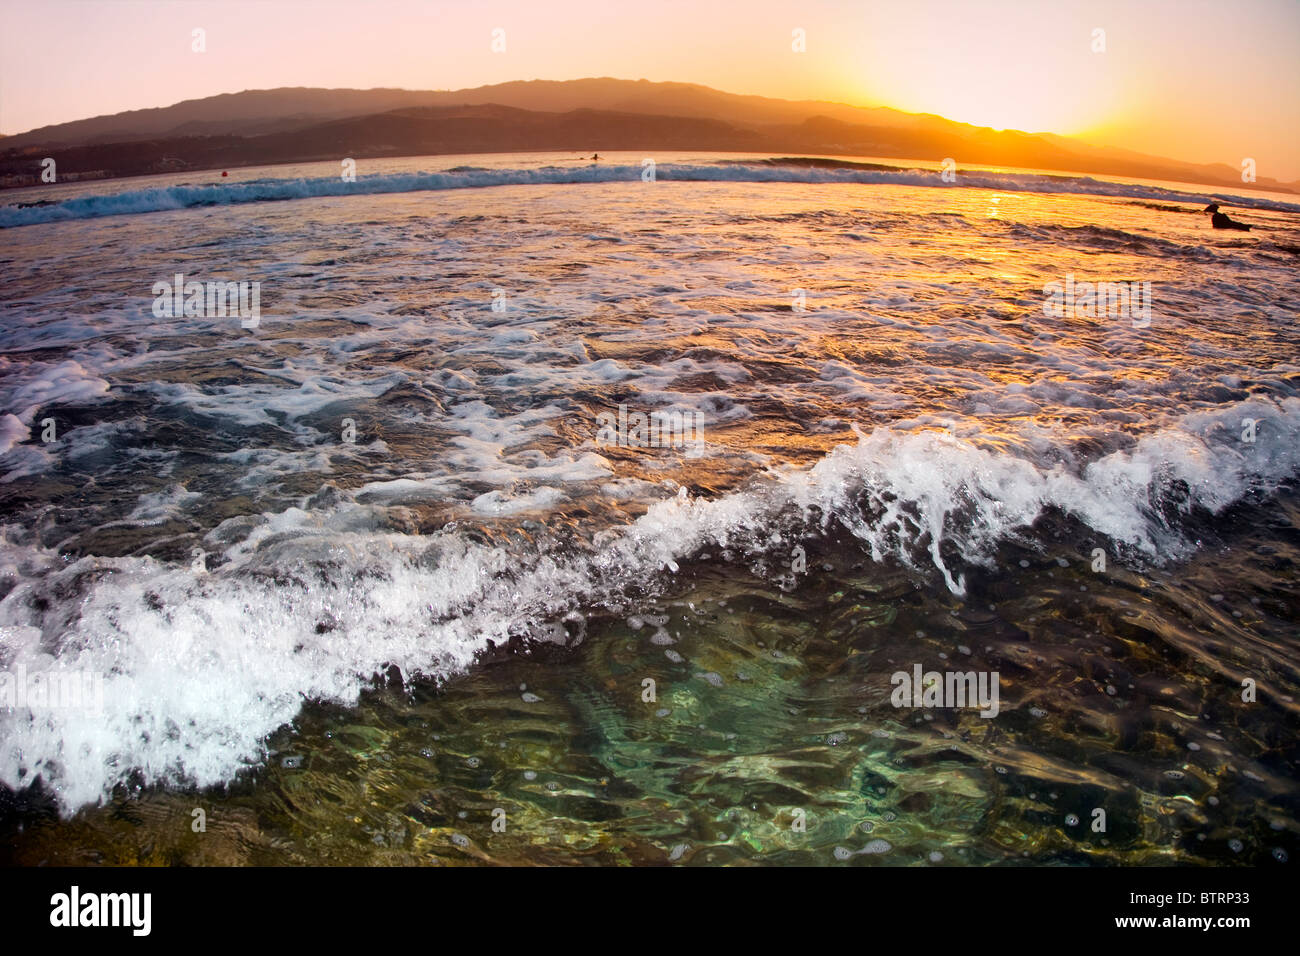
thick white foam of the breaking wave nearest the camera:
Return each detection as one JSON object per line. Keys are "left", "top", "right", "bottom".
{"left": 0, "top": 398, "right": 1300, "bottom": 810}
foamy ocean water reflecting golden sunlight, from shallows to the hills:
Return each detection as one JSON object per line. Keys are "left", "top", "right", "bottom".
{"left": 0, "top": 153, "right": 1300, "bottom": 866}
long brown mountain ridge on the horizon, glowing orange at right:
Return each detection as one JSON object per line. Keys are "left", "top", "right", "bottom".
{"left": 0, "top": 78, "right": 1297, "bottom": 191}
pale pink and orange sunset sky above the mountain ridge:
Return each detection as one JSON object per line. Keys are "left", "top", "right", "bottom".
{"left": 0, "top": 0, "right": 1300, "bottom": 181}
